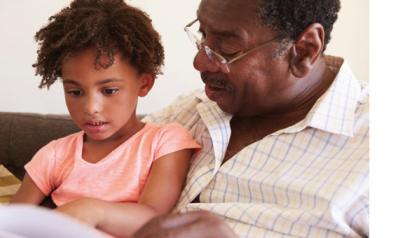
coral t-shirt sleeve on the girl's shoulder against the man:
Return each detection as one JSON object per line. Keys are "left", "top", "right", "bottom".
{"left": 154, "top": 123, "right": 201, "bottom": 159}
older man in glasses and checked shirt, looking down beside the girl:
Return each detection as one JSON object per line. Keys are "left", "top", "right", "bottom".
{"left": 135, "top": 0, "right": 369, "bottom": 238}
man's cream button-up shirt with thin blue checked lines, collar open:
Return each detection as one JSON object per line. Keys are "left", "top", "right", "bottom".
{"left": 145, "top": 56, "right": 369, "bottom": 238}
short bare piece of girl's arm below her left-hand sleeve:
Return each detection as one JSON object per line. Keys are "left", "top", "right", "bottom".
{"left": 10, "top": 173, "right": 46, "bottom": 205}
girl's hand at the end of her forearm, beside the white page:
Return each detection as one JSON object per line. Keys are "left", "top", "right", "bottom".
{"left": 55, "top": 198, "right": 103, "bottom": 227}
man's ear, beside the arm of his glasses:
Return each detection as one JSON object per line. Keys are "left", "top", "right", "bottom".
{"left": 289, "top": 23, "right": 325, "bottom": 78}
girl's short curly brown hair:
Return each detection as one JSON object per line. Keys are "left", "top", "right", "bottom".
{"left": 33, "top": 0, "right": 164, "bottom": 88}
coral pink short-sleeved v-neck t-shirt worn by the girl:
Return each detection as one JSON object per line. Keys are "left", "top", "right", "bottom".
{"left": 25, "top": 123, "right": 200, "bottom": 206}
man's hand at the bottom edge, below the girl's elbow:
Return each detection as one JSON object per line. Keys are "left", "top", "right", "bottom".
{"left": 133, "top": 211, "right": 237, "bottom": 238}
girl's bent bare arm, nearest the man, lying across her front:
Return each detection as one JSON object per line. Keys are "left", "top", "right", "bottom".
{"left": 57, "top": 149, "right": 192, "bottom": 237}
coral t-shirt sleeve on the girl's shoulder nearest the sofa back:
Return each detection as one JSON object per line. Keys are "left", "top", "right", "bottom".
{"left": 25, "top": 141, "right": 56, "bottom": 196}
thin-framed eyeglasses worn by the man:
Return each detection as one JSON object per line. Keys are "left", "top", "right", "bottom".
{"left": 184, "top": 18, "right": 280, "bottom": 66}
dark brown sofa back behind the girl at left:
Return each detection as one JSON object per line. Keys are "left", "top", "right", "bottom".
{"left": 0, "top": 112, "right": 79, "bottom": 179}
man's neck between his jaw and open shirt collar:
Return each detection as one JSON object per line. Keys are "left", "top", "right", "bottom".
{"left": 224, "top": 58, "right": 335, "bottom": 161}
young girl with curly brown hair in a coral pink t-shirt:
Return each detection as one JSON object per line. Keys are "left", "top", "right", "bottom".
{"left": 12, "top": 0, "right": 199, "bottom": 236}
